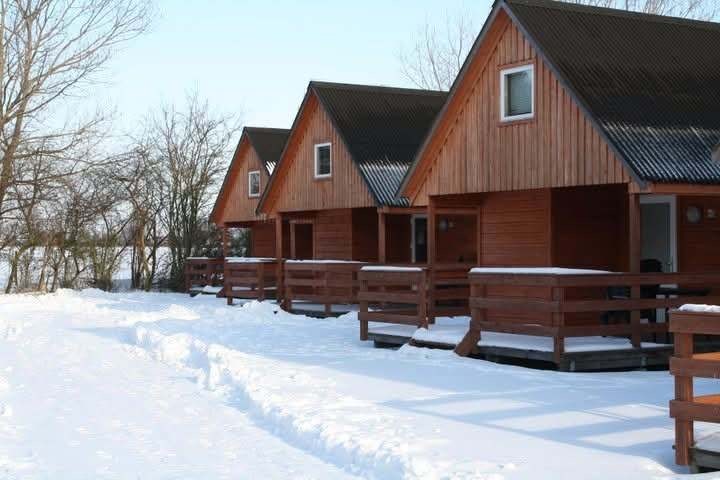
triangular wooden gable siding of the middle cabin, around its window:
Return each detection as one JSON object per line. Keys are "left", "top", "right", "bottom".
{"left": 263, "top": 94, "right": 375, "bottom": 213}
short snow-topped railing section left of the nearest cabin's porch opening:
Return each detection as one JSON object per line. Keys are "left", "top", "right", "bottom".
{"left": 358, "top": 267, "right": 428, "bottom": 340}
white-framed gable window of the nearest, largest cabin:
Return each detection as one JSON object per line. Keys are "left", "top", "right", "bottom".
{"left": 500, "top": 65, "right": 535, "bottom": 122}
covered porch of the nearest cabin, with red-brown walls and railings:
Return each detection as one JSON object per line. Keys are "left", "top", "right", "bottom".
{"left": 360, "top": 184, "right": 720, "bottom": 370}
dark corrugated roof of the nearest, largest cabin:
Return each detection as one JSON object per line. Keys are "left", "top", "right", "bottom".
{"left": 498, "top": 0, "right": 720, "bottom": 184}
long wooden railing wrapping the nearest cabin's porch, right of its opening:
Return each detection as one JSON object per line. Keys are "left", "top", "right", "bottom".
{"left": 455, "top": 269, "right": 720, "bottom": 363}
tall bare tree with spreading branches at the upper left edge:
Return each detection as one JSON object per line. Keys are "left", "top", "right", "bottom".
{"left": 0, "top": 0, "right": 149, "bottom": 233}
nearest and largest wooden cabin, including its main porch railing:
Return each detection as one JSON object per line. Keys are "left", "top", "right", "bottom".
{"left": 361, "top": 0, "right": 720, "bottom": 369}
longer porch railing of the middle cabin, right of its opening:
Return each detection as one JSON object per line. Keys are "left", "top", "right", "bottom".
{"left": 283, "top": 260, "right": 366, "bottom": 316}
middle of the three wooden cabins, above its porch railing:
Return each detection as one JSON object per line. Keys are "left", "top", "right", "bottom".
{"left": 257, "top": 82, "right": 446, "bottom": 263}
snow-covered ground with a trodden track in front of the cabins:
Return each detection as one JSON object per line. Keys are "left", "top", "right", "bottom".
{"left": 0, "top": 290, "right": 717, "bottom": 480}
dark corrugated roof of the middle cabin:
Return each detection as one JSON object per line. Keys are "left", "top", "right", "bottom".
{"left": 309, "top": 82, "right": 447, "bottom": 206}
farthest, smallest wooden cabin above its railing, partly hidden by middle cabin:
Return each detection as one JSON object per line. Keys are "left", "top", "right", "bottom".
{"left": 210, "top": 127, "right": 290, "bottom": 257}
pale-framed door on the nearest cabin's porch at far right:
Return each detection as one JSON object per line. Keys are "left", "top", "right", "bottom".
{"left": 640, "top": 195, "right": 677, "bottom": 273}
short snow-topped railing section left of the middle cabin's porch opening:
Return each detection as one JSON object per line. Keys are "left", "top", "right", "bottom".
{"left": 223, "top": 258, "right": 278, "bottom": 305}
